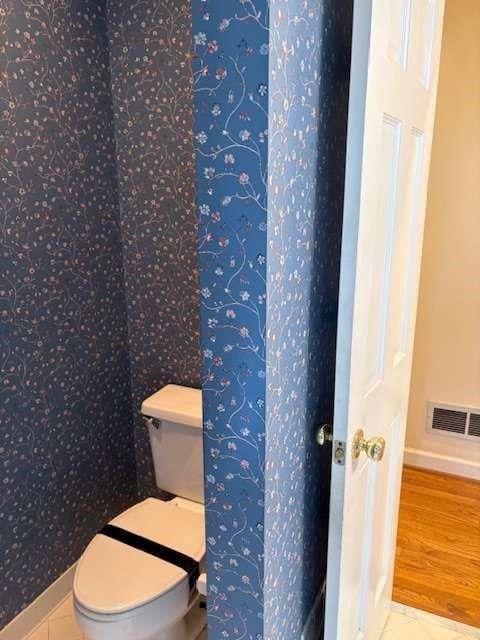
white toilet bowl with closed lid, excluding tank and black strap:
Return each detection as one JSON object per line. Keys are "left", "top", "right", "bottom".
{"left": 73, "top": 498, "right": 205, "bottom": 640}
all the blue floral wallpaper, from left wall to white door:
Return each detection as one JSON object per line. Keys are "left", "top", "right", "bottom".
{"left": 0, "top": 0, "right": 351, "bottom": 640}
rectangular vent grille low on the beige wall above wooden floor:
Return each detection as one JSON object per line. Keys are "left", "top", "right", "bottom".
{"left": 427, "top": 402, "right": 480, "bottom": 440}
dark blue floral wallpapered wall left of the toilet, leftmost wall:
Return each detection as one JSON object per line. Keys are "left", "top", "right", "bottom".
{"left": 0, "top": 0, "right": 136, "bottom": 627}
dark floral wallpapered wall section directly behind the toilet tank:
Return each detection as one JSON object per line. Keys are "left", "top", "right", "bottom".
{"left": 107, "top": 0, "right": 200, "bottom": 495}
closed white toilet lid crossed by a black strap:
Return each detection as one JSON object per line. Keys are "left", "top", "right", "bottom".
{"left": 73, "top": 498, "right": 205, "bottom": 613}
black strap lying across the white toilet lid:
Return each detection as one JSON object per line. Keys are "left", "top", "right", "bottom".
{"left": 98, "top": 524, "right": 200, "bottom": 589}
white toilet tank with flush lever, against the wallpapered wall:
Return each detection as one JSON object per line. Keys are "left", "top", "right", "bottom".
{"left": 142, "top": 384, "right": 204, "bottom": 503}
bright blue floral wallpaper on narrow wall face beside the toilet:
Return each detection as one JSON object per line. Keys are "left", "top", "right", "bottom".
{"left": 193, "top": 0, "right": 268, "bottom": 640}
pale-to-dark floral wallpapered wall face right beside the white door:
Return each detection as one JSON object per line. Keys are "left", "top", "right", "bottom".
{"left": 264, "top": 0, "right": 352, "bottom": 640}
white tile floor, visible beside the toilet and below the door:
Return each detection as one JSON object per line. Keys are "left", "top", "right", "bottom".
{"left": 25, "top": 596, "right": 480, "bottom": 640}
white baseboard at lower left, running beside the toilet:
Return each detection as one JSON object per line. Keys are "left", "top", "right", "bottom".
{"left": 0, "top": 563, "right": 76, "bottom": 640}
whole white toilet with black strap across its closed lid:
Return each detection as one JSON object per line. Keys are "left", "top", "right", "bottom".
{"left": 73, "top": 385, "right": 205, "bottom": 640}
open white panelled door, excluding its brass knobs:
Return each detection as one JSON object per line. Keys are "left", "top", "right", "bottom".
{"left": 325, "top": 0, "right": 444, "bottom": 640}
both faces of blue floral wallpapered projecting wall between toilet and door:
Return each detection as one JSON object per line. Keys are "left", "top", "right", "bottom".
{"left": 193, "top": 0, "right": 352, "bottom": 640}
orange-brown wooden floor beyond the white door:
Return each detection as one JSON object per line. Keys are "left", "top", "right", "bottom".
{"left": 393, "top": 467, "right": 480, "bottom": 627}
